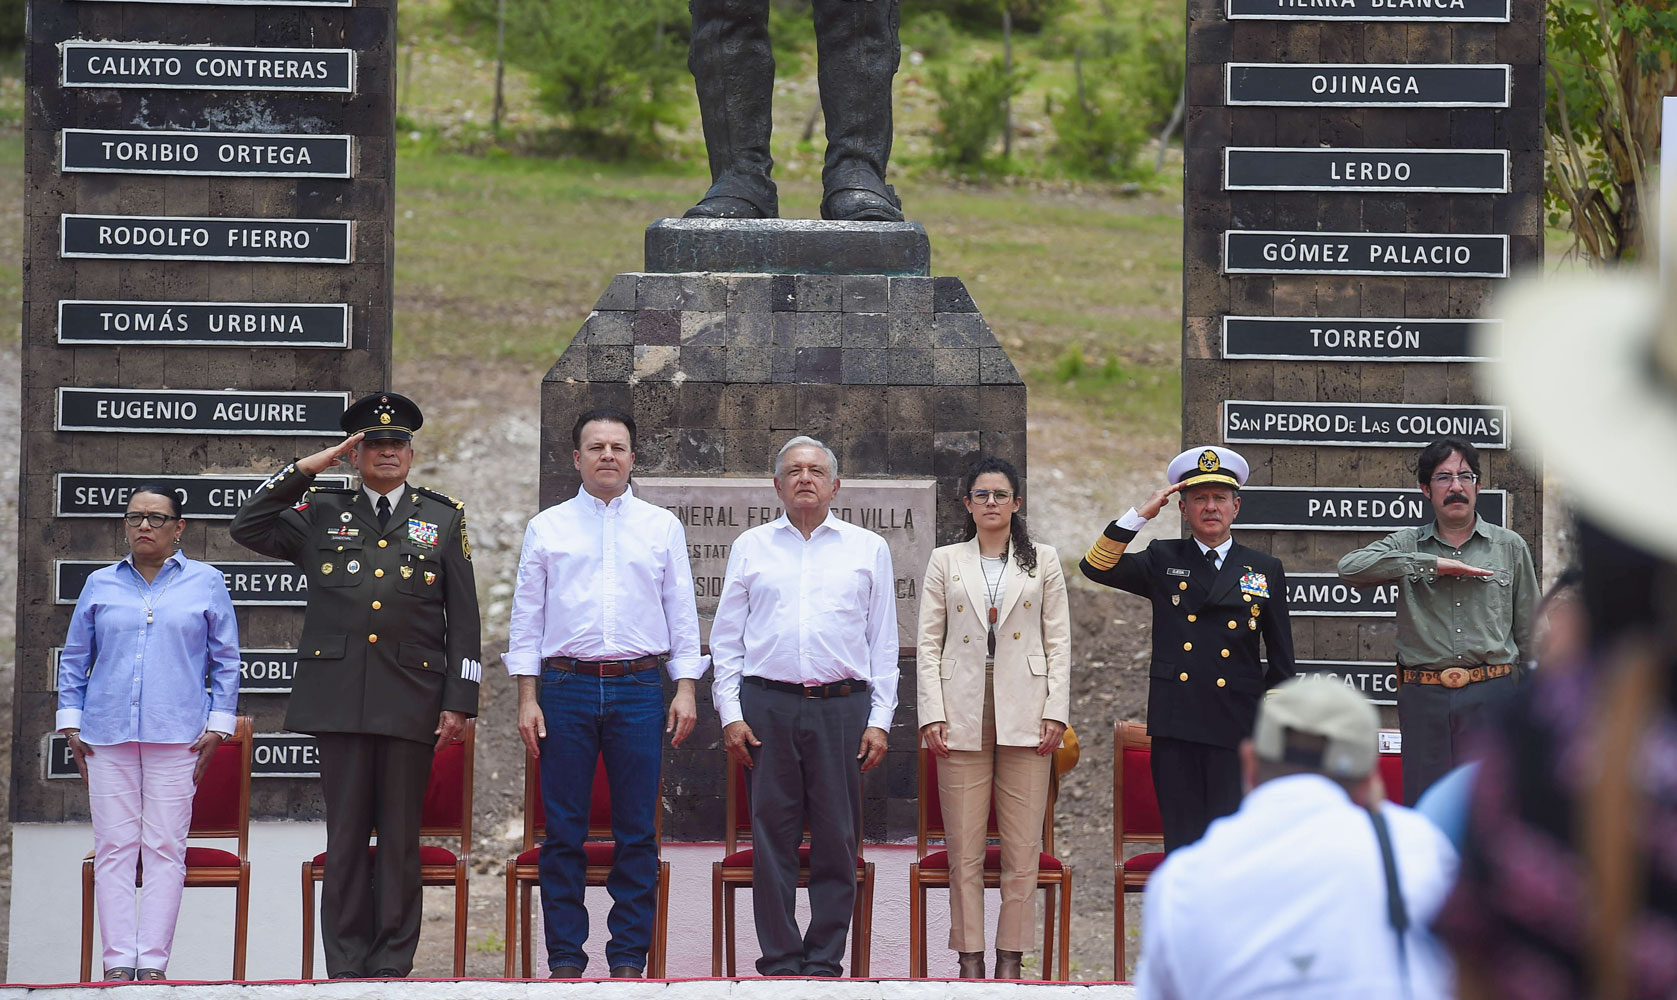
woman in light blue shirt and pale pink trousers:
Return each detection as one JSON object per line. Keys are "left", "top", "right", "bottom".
{"left": 57, "top": 485, "right": 238, "bottom": 980}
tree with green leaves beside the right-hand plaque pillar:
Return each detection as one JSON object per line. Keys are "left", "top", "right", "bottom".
{"left": 1545, "top": 0, "right": 1677, "bottom": 262}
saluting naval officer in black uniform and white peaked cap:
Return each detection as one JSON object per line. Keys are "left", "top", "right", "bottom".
{"left": 1082, "top": 446, "right": 1293, "bottom": 851}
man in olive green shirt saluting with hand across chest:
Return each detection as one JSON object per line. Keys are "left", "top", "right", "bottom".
{"left": 1340, "top": 438, "right": 1538, "bottom": 805}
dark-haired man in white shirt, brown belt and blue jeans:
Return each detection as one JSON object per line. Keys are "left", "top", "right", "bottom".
{"left": 501, "top": 408, "right": 704, "bottom": 978}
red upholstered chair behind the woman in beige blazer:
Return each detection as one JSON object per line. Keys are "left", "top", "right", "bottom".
{"left": 909, "top": 747, "right": 1072, "bottom": 980}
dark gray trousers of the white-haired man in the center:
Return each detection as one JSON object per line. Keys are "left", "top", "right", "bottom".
{"left": 740, "top": 680, "right": 872, "bottom": 977}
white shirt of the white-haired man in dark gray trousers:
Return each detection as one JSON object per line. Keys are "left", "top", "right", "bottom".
{"left": 711, "top": 513, "right": 897, "bottom": 732}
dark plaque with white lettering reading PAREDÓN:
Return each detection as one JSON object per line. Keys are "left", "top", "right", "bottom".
{"left": 1236, "top": 487, "right": 1508, "bottom": 532}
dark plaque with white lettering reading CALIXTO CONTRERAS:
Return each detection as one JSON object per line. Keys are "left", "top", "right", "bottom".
{"left": 59, "top": 40, "right": 356, "bottom": 94}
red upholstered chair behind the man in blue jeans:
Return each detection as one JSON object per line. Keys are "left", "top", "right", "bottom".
{"left": 506, "top": 757, "right": 669, "bottom": 980}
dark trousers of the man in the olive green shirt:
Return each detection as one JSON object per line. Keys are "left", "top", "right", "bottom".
{"left": 1397, "top": 666, "right": 1519, "bottom": 805}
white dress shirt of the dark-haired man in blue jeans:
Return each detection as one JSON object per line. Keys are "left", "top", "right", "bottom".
{"left": 501, "top": 488, "right": 704, "bottom": 680}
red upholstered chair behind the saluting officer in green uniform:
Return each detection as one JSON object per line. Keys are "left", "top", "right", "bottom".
{"left": 302, "top": 718, "right": 478, "bottom": 980}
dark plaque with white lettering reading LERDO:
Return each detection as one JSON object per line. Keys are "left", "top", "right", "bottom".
{"left": 1223, "top": 146, "right": 1508, "bottom": 195}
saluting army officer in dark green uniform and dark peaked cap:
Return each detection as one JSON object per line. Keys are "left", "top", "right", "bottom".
{"left": 231, "top": 393, "right": 483, "bottom": 978}
